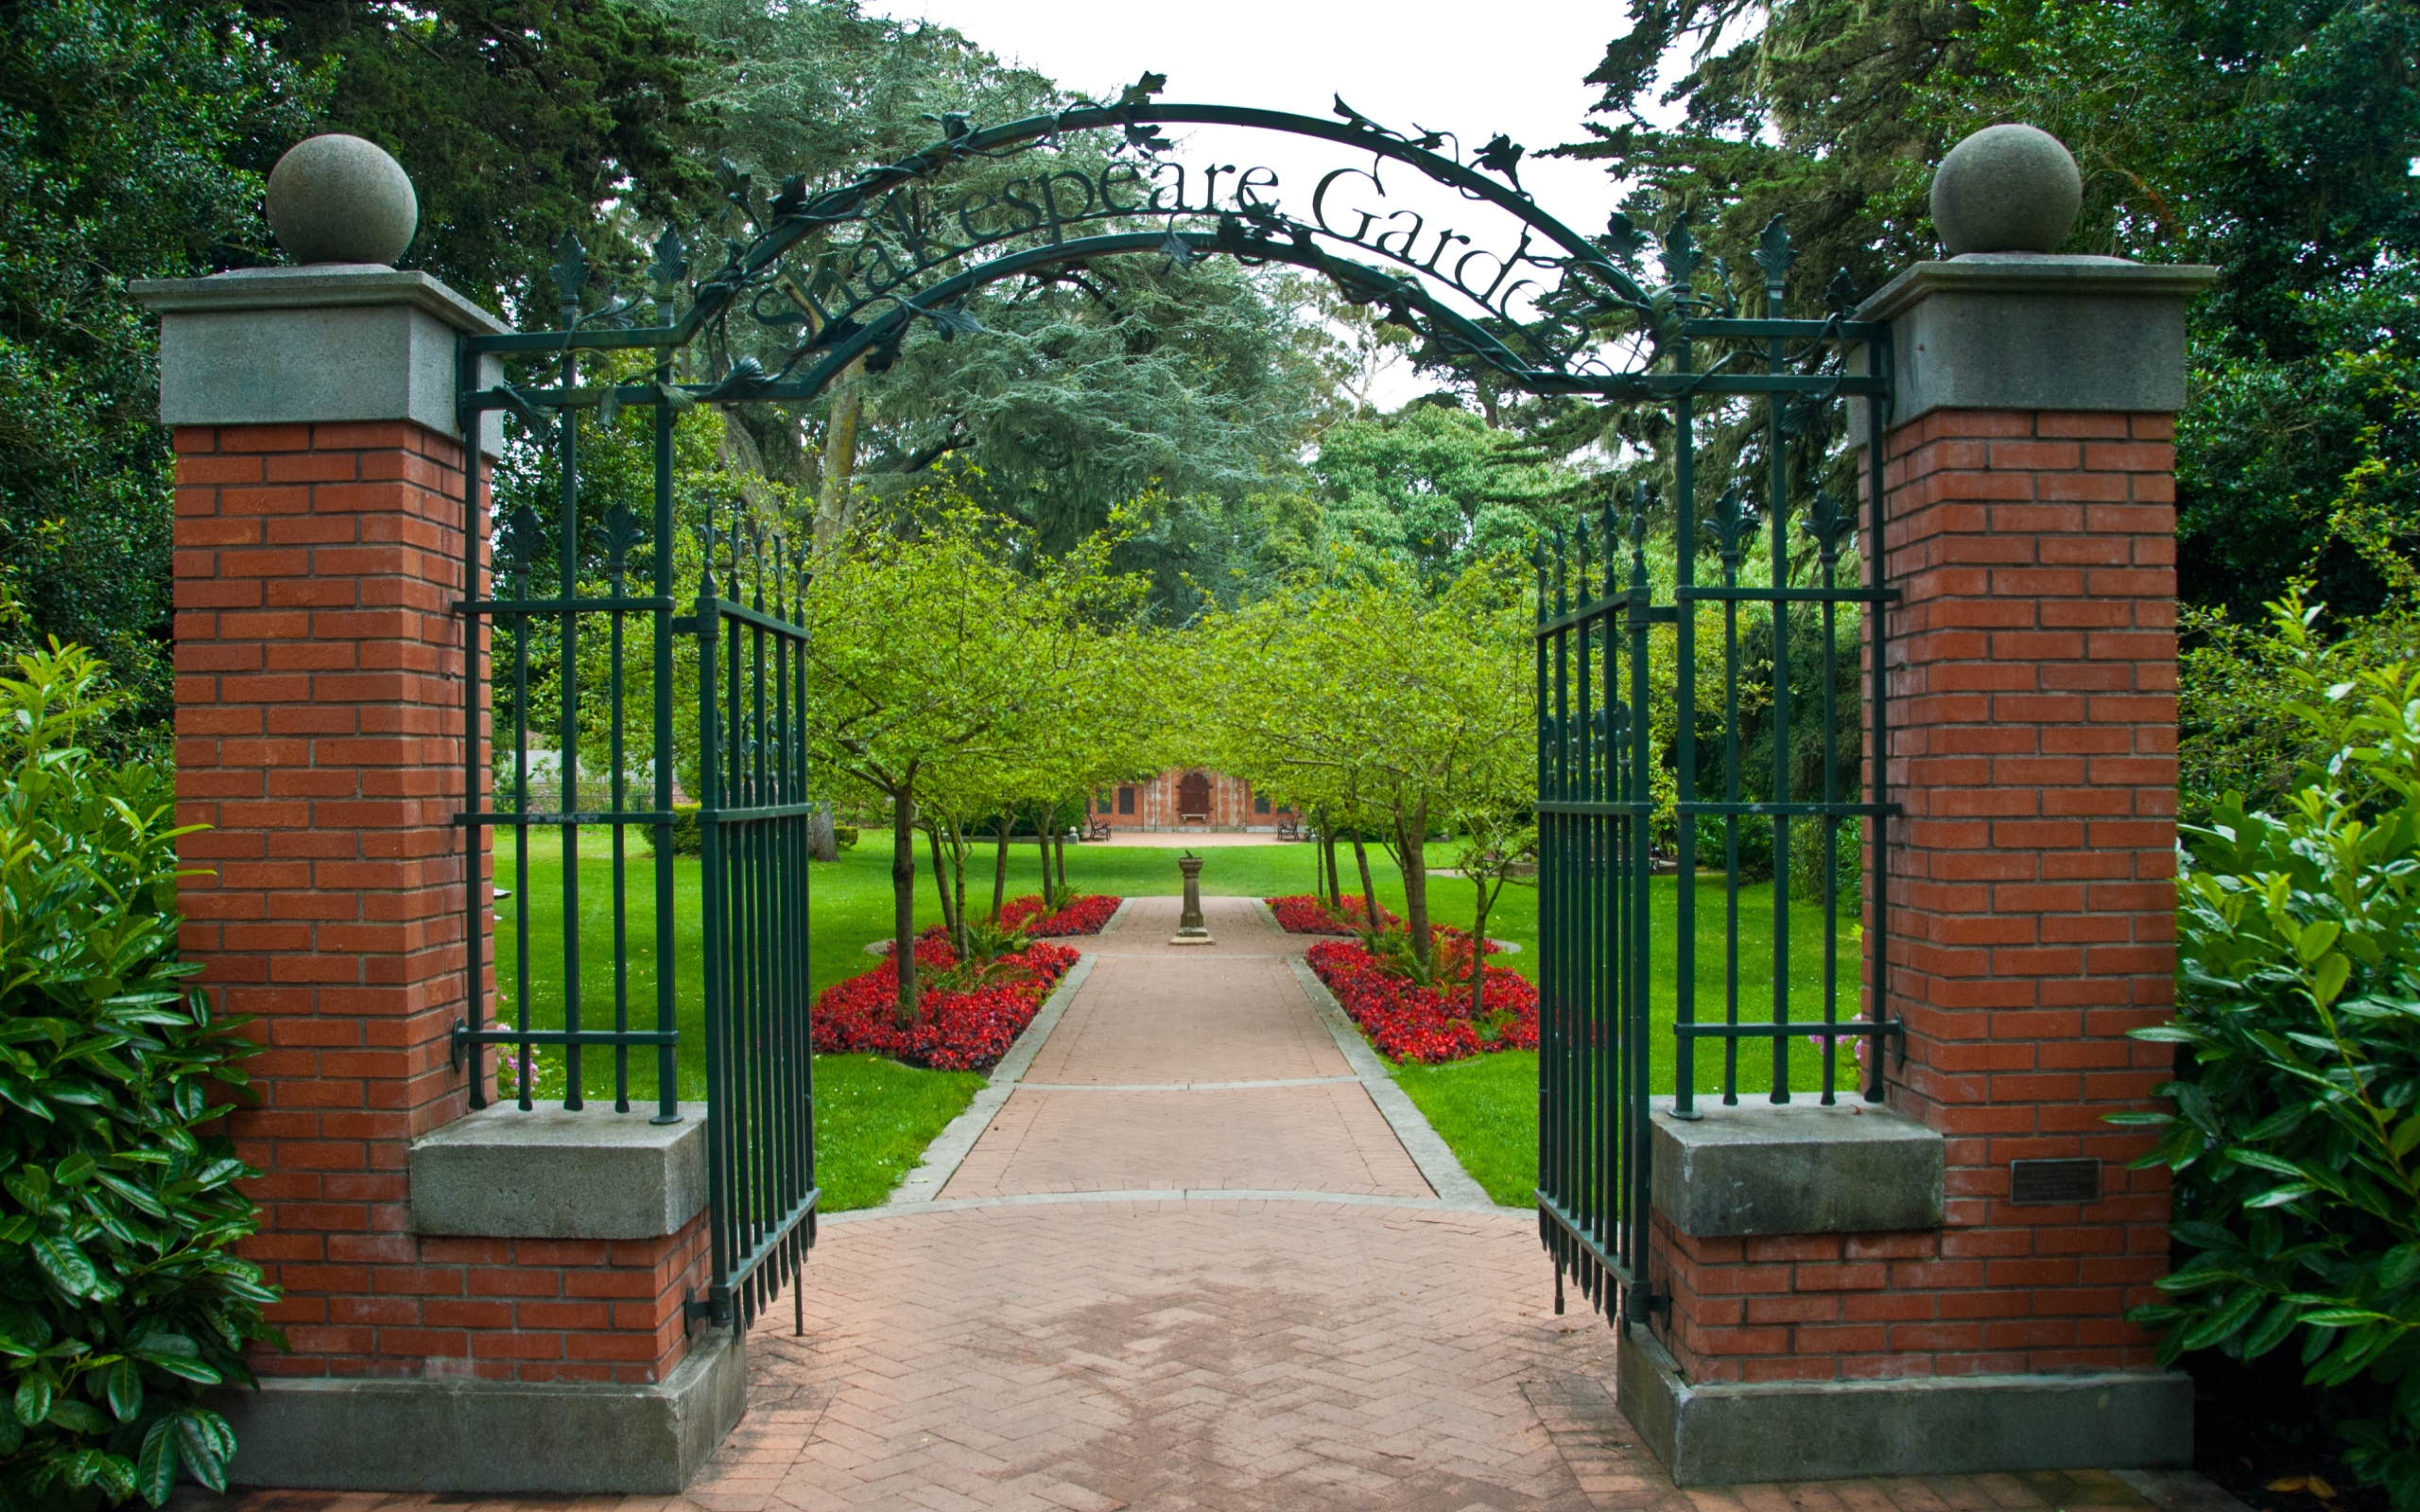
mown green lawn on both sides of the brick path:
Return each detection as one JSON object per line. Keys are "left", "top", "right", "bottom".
{"left": 496, "top": 833, "right": 1857, "bottom": 1212}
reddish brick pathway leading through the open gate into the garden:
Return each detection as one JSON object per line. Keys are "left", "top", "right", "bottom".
{"left": 196, "top": 900, "right": 2216, "bottom": 1512}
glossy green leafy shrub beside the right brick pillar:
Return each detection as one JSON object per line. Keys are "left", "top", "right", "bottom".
{"left": 2120, "top": 648, "right": 2420, "bottom": 1512}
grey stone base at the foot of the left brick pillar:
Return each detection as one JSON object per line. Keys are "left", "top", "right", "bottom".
{"left": 213, "top": 1331, "right": 748, "bottom": 1495}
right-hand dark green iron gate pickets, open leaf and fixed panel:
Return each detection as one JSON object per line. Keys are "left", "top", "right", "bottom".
{"left": 1534, "top": 235, "right": 1894, "bottom": 1318}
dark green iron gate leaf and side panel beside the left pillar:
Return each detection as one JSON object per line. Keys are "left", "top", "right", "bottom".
{"left": 453, "top": 232, "right": 821, "bottom": 1328}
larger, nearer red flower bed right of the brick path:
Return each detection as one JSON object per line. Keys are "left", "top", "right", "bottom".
{"left": 1306, "top": 929, "right": 1537, "bottom": 1064}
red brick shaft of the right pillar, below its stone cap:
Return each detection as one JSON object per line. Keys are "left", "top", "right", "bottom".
{"left": 1885, "top": 409, "right": 2175, "bottom": 1374}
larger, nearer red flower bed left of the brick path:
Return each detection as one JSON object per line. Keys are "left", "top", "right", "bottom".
{"left": 813, "top": 934, "right": 1077, "bottom": 1072}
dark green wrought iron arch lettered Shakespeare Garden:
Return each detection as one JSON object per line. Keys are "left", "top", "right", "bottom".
{"left": 455, "top": 75, "right": 1844, "bottom": 421}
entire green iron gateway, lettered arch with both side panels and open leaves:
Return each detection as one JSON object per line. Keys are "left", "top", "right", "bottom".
{"left": 430, "top": 73, "right": 1890, "bottom": 1323}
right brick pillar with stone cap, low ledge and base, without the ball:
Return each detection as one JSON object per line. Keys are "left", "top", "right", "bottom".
{"left": 1621, "top": 254, "right": 2209, "bottom": 1483}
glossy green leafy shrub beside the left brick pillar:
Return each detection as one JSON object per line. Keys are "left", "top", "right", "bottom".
{"left": 0, "top": 646, "right": 276, "bottom": 1509}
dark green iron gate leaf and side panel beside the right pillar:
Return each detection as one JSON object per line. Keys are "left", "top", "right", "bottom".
{"left": 1534, "top": 220, "right": 1894, "bottom": 1321}
